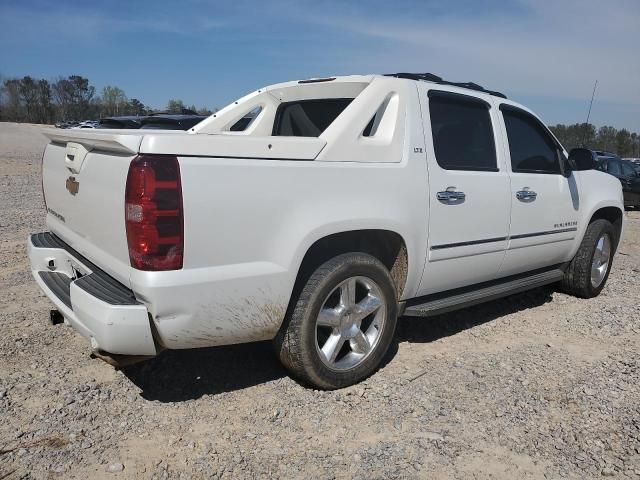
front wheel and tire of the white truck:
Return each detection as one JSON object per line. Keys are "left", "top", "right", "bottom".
{"left": 562, "top": 219, "right": 616, "bottom": 298}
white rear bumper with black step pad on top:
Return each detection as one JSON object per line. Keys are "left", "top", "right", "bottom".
{"left": 27, "top": 232, "right": 158, "bottom": 355}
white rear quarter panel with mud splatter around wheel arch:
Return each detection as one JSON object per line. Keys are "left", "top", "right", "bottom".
{"left": 132, "top": 157, "right": 428, "bottom": 348}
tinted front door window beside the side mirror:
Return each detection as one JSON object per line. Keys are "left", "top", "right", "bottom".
{"left": 502, "top": 108, "right": 560, "bottom": 174}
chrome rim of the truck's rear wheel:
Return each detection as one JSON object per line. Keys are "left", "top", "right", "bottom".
{"left": 316, "top": 277, "right": 388, "bottom": 371}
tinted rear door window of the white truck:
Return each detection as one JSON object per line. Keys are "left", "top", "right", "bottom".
{"left": 429, "top": 90, "right": 498, "bottom": 172}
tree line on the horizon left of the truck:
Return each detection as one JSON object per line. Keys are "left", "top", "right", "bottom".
{"left": 0, "top": 75, "right": 213, "bottom": 124}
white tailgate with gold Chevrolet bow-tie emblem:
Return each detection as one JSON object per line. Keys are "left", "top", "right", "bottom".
{"left": 42, "top": 130, "right": 142, "bottom": 286}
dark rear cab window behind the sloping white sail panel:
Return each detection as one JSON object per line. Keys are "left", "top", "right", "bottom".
{"left": 273, "top": 98, "right": 353, "bottom": 137}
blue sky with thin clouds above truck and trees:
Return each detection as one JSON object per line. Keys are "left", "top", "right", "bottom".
{"left": 0, "top": 0, "right": 640, "bottom": 132}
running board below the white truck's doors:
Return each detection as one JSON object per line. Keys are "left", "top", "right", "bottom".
{"left": 403, "top": 268, "right": 564, "bottom": 317}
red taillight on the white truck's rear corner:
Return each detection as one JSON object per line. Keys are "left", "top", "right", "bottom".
{"left": 124, "top": 155, "right": 184, "bottom": 270}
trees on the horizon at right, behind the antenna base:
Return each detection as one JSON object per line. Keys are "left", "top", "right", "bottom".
{"left": 549, "top": 123, "right": 640, "bottom": 158}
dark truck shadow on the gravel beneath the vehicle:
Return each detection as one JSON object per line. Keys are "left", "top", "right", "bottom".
{"left": 122, "top": 288, "right": 553, "bottom": 403}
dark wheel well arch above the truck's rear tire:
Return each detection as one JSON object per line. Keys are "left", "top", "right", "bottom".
{"left": 292, "top": 230, "right": 409, "bottom": 298}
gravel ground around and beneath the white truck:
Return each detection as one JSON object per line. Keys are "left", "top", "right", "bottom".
{"left": 0, "top": 123, "right": 640, "bottom": 479}
